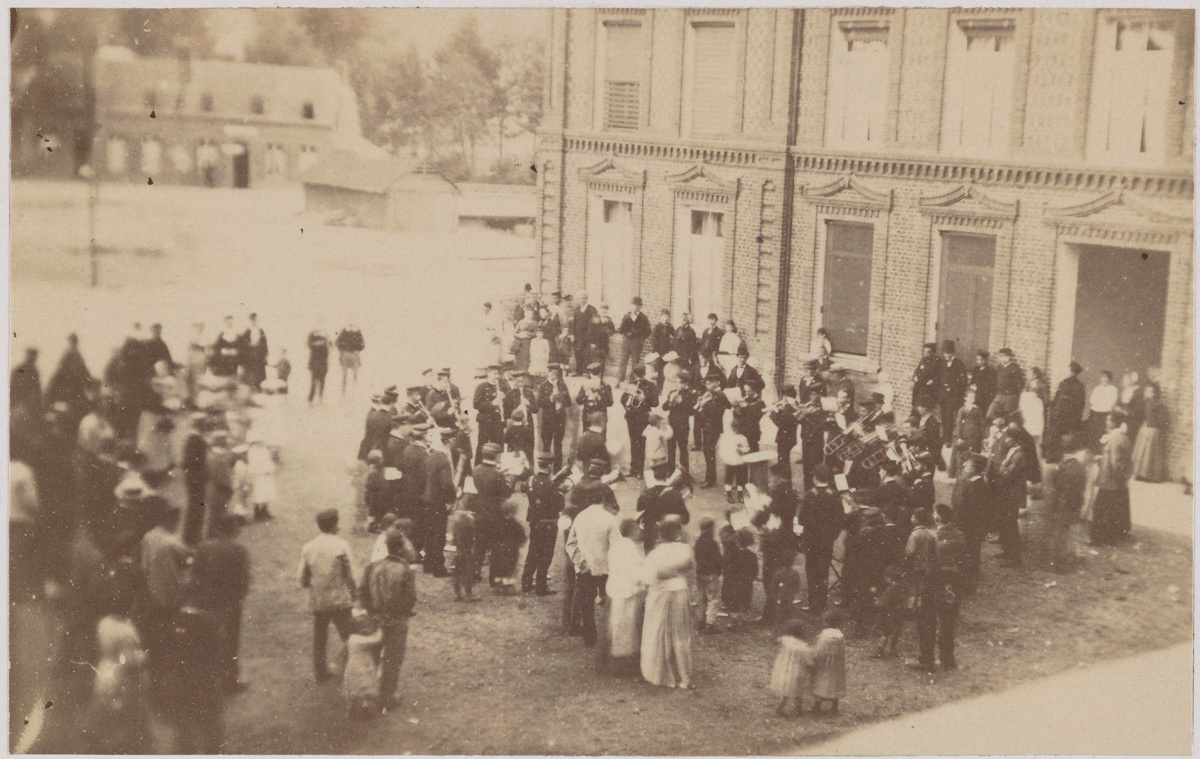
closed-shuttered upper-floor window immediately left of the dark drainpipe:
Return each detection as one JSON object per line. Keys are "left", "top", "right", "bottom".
{"left": 689, "top": 24, "right": 738, "bottom": 137}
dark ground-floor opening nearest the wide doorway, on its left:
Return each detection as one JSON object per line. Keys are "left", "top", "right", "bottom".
{"left": 937, "top": 233, "right": 996, "bottom": 365}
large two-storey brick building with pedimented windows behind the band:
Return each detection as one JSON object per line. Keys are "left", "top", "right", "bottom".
{"left": 538, "top": 8, "right": 1194, "bottom": 477}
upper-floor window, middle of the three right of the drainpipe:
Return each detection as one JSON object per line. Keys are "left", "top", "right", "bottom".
{"left": 942, "top": 20, "right": 1014, "bottom": 154}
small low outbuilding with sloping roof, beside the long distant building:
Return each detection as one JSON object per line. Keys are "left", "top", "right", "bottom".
{"left": 300, "top": 150, "right": 460, "bottom": 232}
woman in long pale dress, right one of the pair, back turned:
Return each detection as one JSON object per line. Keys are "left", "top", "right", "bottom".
{"left": 642, "top": 515, "right": 696, "bottom": 688}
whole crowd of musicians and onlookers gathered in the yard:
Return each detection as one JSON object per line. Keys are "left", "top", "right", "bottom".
{"left": 10, "top": 286, "right": 1169, "bottom": 753}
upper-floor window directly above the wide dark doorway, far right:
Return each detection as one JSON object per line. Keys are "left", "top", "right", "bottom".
{"left": 1087, "top": 17, "right": 1175, "bottom": 159}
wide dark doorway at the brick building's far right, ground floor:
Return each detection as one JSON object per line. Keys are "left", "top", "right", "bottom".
{"left": 1072, "top": 245, "right": 1170, "bottom": 387}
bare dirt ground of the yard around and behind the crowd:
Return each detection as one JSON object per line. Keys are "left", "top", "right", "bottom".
{"left": 12, "top": 178, "right": 1193, "bottom": 755}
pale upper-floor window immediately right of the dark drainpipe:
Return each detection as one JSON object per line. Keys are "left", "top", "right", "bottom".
{"left": 826, "top": 22, "right": 890, "bottom": 148}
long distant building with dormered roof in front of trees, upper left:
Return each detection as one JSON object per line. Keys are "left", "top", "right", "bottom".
{"left": 92, "top": 48, "right": 386, "bottom": 187}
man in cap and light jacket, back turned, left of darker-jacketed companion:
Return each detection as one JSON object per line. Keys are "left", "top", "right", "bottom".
{"left": 296, "top": 509, "right": 356, "bottom": 682}
